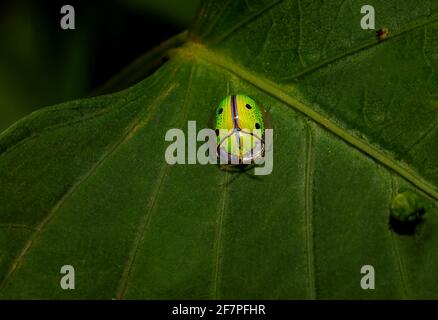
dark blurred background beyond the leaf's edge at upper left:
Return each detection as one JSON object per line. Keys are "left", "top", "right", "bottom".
{"left": 0, "top": 0, "right": 200, "bottom": 132}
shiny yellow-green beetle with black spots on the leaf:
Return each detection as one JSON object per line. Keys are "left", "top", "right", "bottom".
{"left": 214, "top": 94, "right": 266, "bottom": 164}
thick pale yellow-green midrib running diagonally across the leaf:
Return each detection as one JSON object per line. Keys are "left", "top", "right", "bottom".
{"left": 170, "top": 42, "right": 438, "bottom": 201}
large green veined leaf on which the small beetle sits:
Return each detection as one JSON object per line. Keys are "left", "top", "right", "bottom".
{"left": 0, "top": 0, "right": 438, "bottom": 299}
